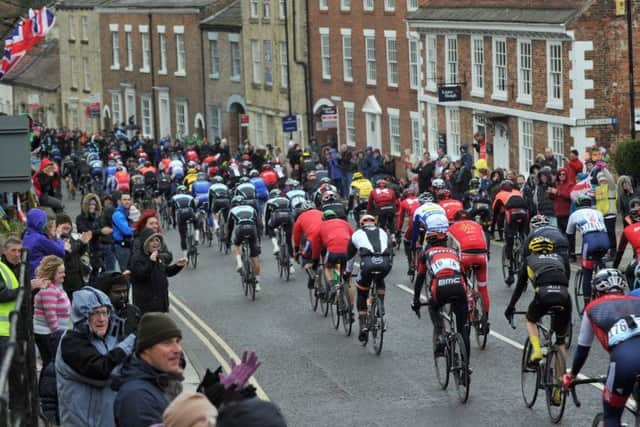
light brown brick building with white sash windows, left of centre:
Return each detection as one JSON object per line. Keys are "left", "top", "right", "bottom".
{"left": 96, "top": 0, "right": 229, "bottom": 139}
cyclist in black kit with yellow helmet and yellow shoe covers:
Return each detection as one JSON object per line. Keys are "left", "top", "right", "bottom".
{"left": 504, "top": 236, "right": 571, "bottom": 364}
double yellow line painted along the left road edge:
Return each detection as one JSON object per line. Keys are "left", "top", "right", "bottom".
{"left": 169, "top": 292, "right": 269, "bottom": 400}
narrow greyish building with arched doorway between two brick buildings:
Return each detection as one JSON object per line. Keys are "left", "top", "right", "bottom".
{"left": 200, "top": 0, "right": 247, "bottom": 149}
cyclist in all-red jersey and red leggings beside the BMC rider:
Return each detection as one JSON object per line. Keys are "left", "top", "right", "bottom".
{"left": 449, "top": 210, "right": 490, "bottom": 334}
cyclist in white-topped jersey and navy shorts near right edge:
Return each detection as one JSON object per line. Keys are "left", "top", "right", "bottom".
{"left": 567, "top": 194, "right": 610, "bottom": 305}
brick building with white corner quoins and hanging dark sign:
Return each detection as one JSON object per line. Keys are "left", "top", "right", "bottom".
{"left": 408, "top": 0, "right": 638, "bottom": 175}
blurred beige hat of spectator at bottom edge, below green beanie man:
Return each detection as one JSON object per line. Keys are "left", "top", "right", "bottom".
{"left": 158, "top": 392, "right": 218, "bottom": 427}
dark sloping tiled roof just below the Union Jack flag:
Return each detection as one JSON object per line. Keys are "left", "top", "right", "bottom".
{"left": 1, "top": 39, "right": 60, "bottom": 91}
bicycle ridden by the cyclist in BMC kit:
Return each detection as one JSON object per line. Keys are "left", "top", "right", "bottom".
{"left": 422, "top": 302, "right": 471, "bottom": 403}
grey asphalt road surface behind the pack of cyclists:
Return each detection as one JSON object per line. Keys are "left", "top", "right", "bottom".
{"left": 62, "top": 192, "right": 629, "bottom": 427}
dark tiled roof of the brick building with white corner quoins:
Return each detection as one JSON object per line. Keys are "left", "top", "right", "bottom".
{"left": 407, "top": 1, "right": 582, "bottom": 24}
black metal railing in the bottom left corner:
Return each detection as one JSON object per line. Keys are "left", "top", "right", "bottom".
{"left": 0, "top": 250, "right": 39, "bottom": 427}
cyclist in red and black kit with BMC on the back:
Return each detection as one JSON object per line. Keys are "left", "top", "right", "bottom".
{"left": 418, "top": 227, "right": 470, "bottom": 357}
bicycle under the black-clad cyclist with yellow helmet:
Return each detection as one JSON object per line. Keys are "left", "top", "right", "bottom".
{"left": 510, "top": 306, "right": 566, "bottom": 424}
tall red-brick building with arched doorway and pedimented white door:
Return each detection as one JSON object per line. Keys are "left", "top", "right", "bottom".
{"left": 309, "top": 0, "right": 423, "bottom": 160}
